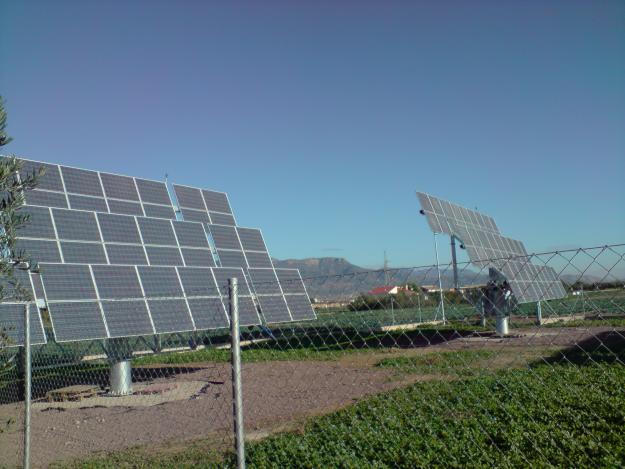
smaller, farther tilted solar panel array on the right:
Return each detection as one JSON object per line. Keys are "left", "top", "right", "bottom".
{"left": 417, "top": 192, "right": 566, "bottom": 303}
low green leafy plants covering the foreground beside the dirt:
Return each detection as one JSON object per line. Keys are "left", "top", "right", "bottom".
{"left": 57, "top": 348, "right": 625, "bottom": 469}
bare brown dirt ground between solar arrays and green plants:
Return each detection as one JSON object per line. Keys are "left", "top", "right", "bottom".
{"left": 0, "top": 328, "right": 612, "bottom": 467}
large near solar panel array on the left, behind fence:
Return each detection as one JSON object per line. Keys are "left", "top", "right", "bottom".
{"left": 0, "top": 160, "right": 315, "bottom": 342}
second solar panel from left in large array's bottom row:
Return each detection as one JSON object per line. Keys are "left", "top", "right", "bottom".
{"left": 44, "top": 302, "right": 108, "bottom": 342}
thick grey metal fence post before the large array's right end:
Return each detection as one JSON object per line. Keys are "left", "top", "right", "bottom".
{"left": 228, "top": 278, "right": 245, "bottom": 469}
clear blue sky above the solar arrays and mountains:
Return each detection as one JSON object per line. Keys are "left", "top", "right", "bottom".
{"left": 0, "top": 0, "right": 625, "bottom": 267}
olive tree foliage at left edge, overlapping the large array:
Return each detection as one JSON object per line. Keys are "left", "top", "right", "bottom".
{"left": 0, "top": 96, "right": 43, "bottom": 348}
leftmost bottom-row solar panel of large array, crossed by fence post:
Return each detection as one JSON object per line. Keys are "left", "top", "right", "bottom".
{"left": 0, "top": 303, "right": 46, "bottom": 349}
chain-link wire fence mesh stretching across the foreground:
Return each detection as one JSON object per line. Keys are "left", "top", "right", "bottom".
{"left": 0, "top": 245, "right": 625, "bottom": 467}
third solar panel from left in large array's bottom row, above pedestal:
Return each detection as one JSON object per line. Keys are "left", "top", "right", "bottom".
{"left": 102, "top": 300, "right": 155, "bottom": 337}
